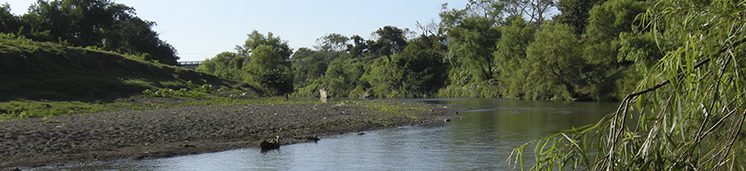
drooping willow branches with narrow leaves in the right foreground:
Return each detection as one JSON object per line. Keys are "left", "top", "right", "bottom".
{"left": 509, "top": 0, "right": 746, "bottom": 170}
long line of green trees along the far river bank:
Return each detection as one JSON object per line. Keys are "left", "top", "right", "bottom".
{"left": 198, "top": 0, "right": 652, "bottom": 101}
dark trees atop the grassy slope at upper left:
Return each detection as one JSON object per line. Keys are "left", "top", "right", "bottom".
{"left": 0, "top": 0, "right": 179, "bottom": 65}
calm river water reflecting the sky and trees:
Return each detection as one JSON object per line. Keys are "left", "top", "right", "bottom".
{"left": 38, "top": 99, "right": 617, "bottom": 171}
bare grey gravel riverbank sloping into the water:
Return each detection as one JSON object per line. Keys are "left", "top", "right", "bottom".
{"left": 0, "top": 102, "right": 455, "bottom": 169}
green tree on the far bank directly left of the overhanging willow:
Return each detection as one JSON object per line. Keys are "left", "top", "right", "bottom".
{"left": 583, "top": 0, "right": 647, "bottom": 100}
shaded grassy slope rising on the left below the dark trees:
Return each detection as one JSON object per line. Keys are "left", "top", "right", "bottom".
{"left": 0, "top": 39, "right": 235, "bottom": 102}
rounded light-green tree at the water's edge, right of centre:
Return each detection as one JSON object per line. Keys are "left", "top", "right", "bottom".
{"left": 524, "top": 22, "right": 584, "bottom": 100}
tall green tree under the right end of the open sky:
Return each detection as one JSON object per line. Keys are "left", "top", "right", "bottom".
{"left": 438, "top": 0, "right": 502, "bottom": 97}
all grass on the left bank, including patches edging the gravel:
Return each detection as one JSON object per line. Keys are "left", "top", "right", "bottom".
{"left": 0, "top": 38, "right": 436, "bottom": 121}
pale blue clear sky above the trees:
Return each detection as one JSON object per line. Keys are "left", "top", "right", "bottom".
{"left": 5, "top": 0, "right": 467, "bottom": 61}
